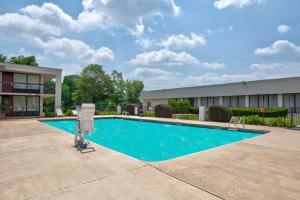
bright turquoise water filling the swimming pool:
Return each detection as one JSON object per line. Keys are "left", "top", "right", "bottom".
{"left": 42, "top": 118, "right": 259, "bottom": 161}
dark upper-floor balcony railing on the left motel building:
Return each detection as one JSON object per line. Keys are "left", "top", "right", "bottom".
{"left": 0, "top": 81, "right": 55, "bottom": 94}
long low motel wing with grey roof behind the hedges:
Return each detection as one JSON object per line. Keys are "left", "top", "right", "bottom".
{"left": 141, "top": 77, "right": 300, "bottom": 109}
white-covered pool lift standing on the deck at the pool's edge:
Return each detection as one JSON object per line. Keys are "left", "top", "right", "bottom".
{"left": 74, "top": 104, "right": 95, "bottom": 149}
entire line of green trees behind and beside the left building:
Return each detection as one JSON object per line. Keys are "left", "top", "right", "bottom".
{"left": 0, "top": 54, "right": 144, "bottom": 112}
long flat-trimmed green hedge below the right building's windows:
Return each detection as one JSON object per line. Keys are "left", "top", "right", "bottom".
{"left": 229, "top": 107, "right": 288, "bottom": 117}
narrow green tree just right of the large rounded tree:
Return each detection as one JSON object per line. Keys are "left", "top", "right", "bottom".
{"left": 110, "top": 70, "right": 126, "bottom": 105}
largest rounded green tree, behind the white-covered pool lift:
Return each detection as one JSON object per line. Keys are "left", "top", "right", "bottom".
{"left": 73, "top": 64, "right": 113, "bottom": 104}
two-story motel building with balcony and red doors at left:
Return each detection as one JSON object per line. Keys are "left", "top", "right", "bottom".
{"left": 0, "top": 63, "right": 62, "bottom": 117}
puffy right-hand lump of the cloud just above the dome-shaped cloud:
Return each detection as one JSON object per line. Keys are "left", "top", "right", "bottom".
{"left": 162, "top": 33, "right": 206, "bottom": 49}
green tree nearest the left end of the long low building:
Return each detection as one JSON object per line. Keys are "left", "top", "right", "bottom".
{"left": 125, "top": 80, "right": 144, "bottom": 104}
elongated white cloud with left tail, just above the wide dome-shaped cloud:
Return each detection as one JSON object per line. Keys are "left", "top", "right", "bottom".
{"left": 136, "top": 33, "right": 206, "bottom": 50}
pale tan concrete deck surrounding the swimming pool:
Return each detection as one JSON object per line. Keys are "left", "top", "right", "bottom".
{"left": 0, "top": 117, "right": 300, "bottom": 200}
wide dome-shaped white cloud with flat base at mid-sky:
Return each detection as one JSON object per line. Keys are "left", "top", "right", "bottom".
{"left": 127, "top": 49, "right": 200, "bottom": 67}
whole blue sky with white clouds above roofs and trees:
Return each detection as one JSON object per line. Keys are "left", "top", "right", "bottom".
{"left": 0, "top": 0, "right": 300, "bottom": 90}
